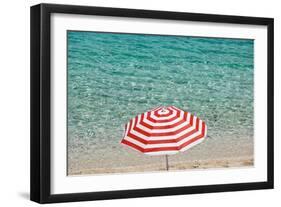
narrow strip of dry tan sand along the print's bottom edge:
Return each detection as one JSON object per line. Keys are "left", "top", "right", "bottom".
{"left": 67, "top": 156, "right": 254, "bottom": 176}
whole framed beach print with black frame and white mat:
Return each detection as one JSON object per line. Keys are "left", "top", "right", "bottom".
{"left": 31, "top": 4, "right": 273, "bottom": 203}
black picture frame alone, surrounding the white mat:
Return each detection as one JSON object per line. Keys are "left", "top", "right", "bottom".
{"left": 30, "top": 4, "right": 274, "bottom": 203}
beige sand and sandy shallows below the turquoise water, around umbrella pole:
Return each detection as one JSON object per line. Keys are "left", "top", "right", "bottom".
{"left": 68, "top": 137, "right": 254, "bottom": 176}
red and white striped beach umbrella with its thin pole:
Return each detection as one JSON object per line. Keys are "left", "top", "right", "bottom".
{"left": 121, "top": 106, "right": 207, "bottom": 170}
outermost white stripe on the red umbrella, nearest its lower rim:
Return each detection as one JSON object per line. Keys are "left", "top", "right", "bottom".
{"left": 124, "top": 120, "right": 204, "bottom": 149}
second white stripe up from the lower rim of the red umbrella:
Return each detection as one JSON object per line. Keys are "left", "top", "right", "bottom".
{"left": 130, "top": 116, "right": 197, "bottom": 140}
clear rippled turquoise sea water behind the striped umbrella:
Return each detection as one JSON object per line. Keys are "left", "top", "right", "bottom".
{"left": 67, "top": 31, "right": 254, "bottom": 173}
